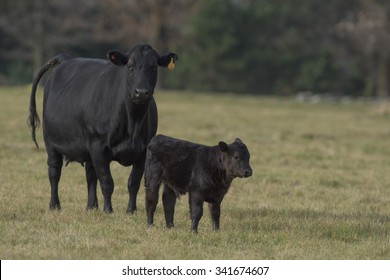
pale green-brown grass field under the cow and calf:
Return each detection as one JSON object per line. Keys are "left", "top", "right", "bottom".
{"left": 0, "top": 87, "right": 390, "bottom": 259}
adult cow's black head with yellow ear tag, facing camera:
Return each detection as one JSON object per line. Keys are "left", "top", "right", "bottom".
{"left": 107, "top": 45, "right": 178, "bottom": 104}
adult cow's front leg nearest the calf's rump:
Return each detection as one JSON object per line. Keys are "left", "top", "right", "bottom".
{"left": 126, "top": 155, "right": 145, "bottom": 213}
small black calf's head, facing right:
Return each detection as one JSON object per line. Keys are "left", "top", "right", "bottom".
{"left": 218, "top": 138, "right": 252, "bottom": 178}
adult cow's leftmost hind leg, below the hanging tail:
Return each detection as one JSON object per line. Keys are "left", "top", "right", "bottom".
{"left": 47, "top": 148, "right": 63, "bottom": 210}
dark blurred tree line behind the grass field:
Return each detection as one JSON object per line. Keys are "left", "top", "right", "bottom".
{"left": 0, "top": 0, "right": 390, "bottom": 96}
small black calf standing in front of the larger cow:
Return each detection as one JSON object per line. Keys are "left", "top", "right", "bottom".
{"left": 145, "top": 135, "right": 252, "bottom": 233}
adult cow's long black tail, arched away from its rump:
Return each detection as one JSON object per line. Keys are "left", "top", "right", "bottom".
{"left": 27, "top": 54, "right": 69, "bottom": 149}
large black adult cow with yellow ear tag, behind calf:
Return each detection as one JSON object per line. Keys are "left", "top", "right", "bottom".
{"left": 28, "top": 45, "right": 178, "bottom": 213}
